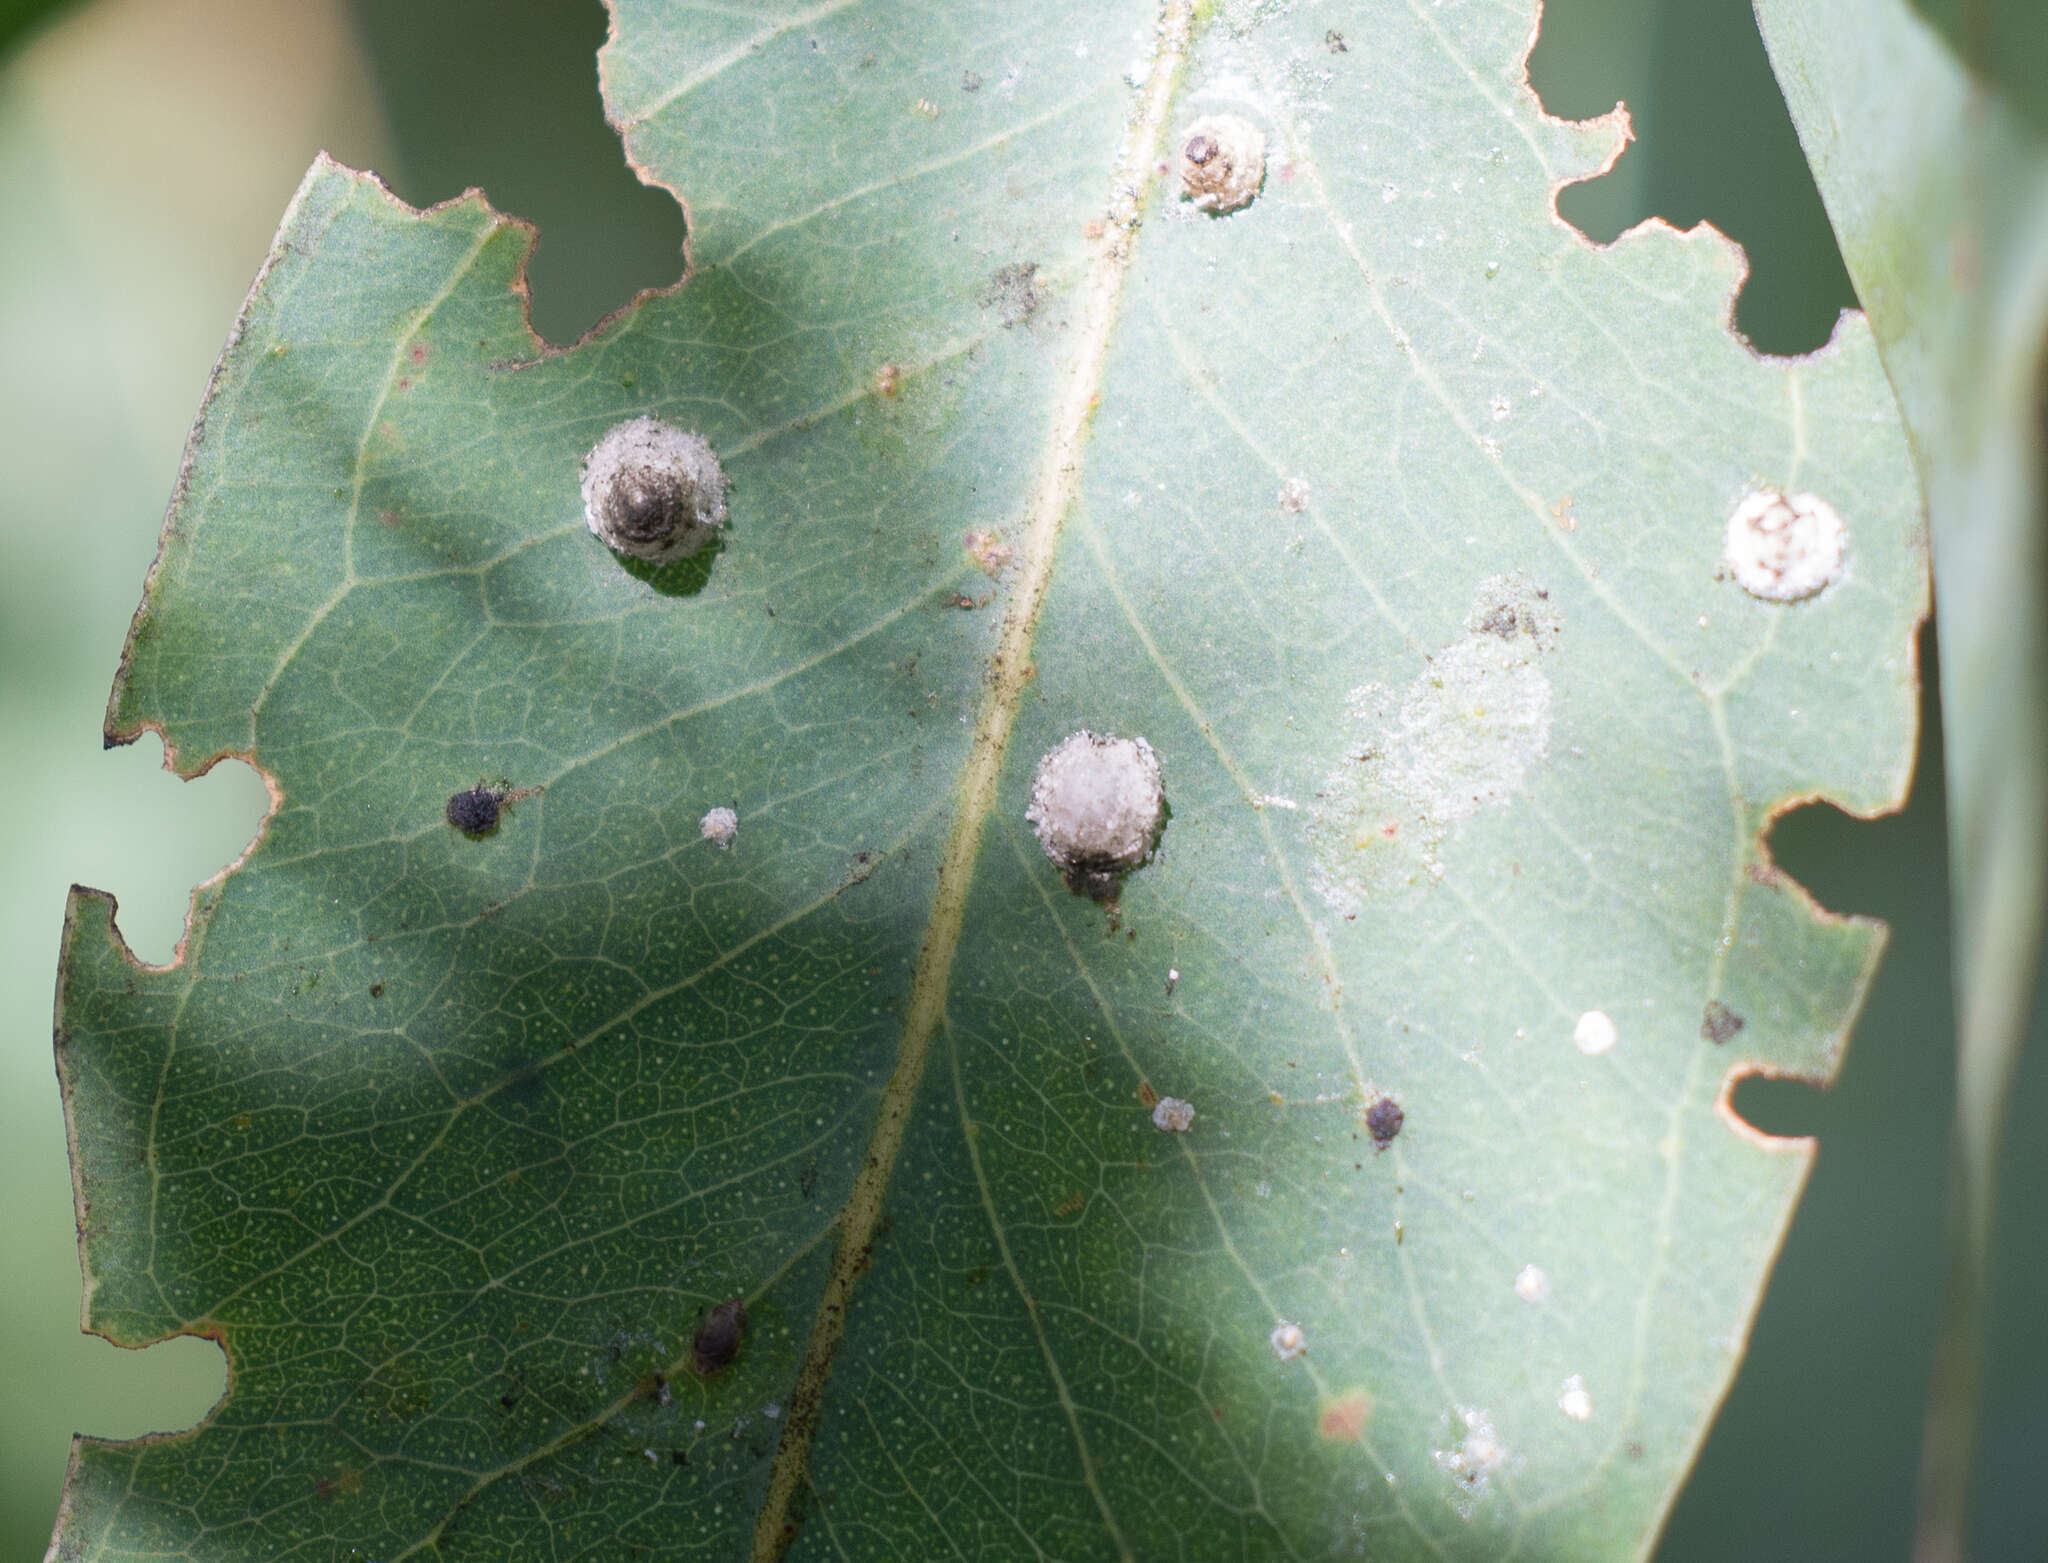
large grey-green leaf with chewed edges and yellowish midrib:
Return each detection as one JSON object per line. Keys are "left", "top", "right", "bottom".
{"left": 57, "top": 0, "right": 1925, "bottom": 1563}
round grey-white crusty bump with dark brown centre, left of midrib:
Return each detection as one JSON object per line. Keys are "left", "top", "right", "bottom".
{"left": 584, "top": 418, "right": 727, "bottom": 565}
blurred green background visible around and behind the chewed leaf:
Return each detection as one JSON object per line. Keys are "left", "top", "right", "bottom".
{"left": 0, "top": 0, "right": 2048, "bottom": 1563}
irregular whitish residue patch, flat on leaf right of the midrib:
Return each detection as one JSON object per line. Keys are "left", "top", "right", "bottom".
{"left": 1307, "top": 576, "right": 1559, "bottom": 916}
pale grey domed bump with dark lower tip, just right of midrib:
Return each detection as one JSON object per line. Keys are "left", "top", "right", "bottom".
{"left": 1024, "top": 727, "right": 1165, "bottom": 901}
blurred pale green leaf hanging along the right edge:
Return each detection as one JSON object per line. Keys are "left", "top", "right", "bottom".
{"left": 1757, "top": 0, "right": 2048, "bottom": 1559}
